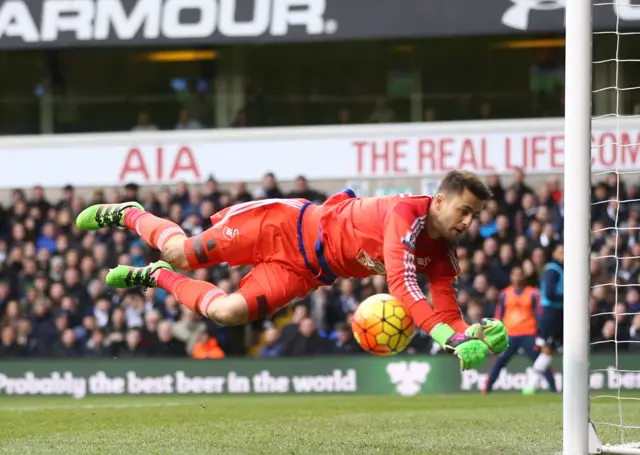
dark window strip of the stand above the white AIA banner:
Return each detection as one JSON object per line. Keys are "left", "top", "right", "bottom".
{"left": 0, "top": 37, "right": 576, "bottom": 134}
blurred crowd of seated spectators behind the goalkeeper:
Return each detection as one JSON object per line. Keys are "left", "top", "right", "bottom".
{"left": 0, "top": 167, "right": 640, "bottom": 359}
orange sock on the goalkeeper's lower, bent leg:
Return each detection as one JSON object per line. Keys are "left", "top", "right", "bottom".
{"left": 157, "top": 269, "right": 227, "bottom": 318}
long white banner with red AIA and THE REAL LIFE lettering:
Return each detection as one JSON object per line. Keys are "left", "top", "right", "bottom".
{"left": 0, "top": 119, "right": 640, "bottom": 188}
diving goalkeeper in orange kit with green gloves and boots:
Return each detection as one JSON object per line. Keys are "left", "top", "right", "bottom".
{"left": 76, "top": 171, "right": 508, "bottom": 369}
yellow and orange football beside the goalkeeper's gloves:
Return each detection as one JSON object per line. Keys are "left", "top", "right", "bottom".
{"left": 351, "top": 294, "right": 414, "bottom": 356}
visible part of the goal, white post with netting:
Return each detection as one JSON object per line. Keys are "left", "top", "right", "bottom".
{"left": 563, "top": 0, "right": 640, "bottom": 454}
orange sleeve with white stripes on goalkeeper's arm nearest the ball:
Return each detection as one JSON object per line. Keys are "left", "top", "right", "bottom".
{"left": 384, "top": 202, "right": 458, "bottom": 333}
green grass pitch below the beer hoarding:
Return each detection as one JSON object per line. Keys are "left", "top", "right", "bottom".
{"left": 0, "top": 394, "right": 640, "bottom": 455}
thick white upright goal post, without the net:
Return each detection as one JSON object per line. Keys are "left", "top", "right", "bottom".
{"left": 562, "top": 0, "right": 593, "bottom": 455}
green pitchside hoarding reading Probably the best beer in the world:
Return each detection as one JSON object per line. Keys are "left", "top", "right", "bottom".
{"left": 0, "top": 355, "right": 640, "bottom": 398}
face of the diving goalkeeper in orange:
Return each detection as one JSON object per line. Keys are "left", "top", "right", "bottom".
{"left": 435, "top": 189, "right": 484, "bottom": 240}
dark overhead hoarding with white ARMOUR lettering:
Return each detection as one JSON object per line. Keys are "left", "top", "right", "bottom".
{"left": 0, "top": 0, "right": 640, "bottom": 49}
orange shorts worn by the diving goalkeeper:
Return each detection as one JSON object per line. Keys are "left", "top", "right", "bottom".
{"left": 185, "top": 199, "right": 329, "bottom": 320}
